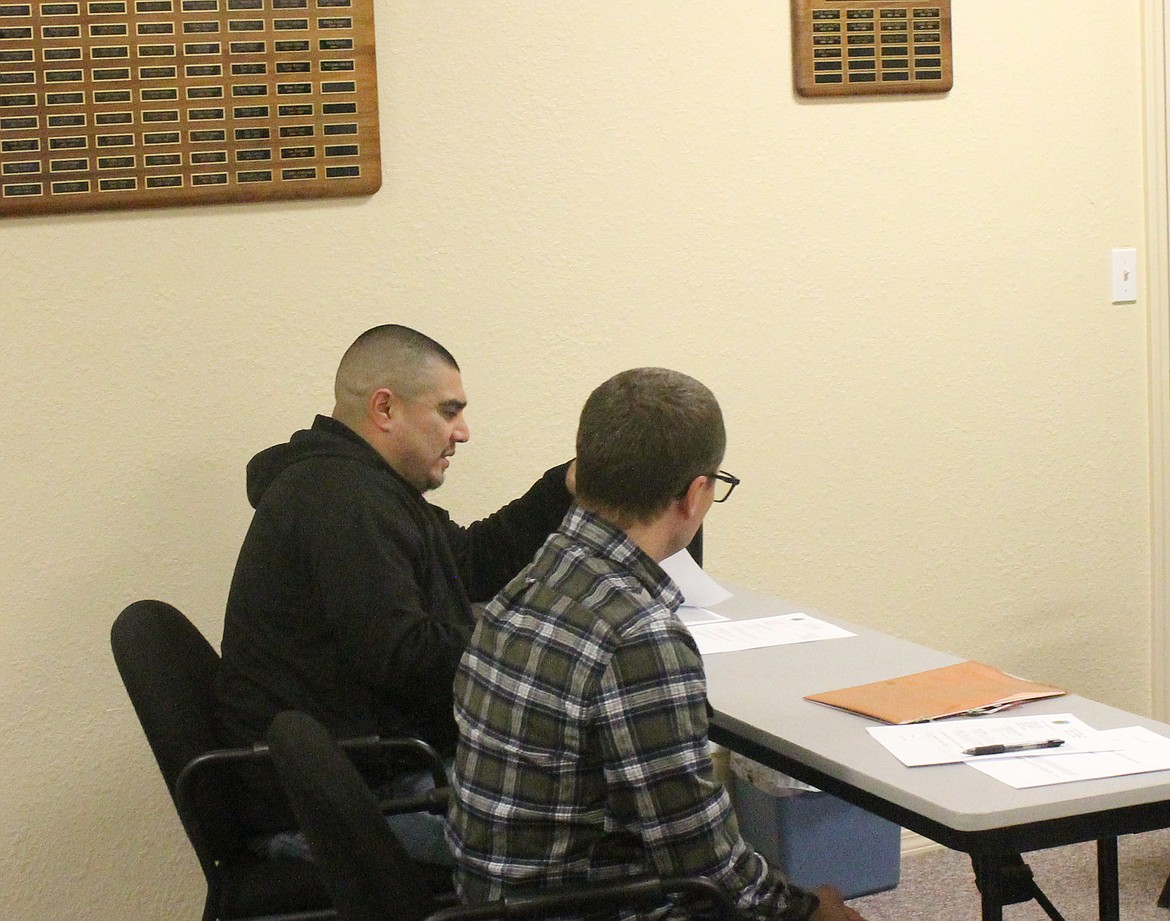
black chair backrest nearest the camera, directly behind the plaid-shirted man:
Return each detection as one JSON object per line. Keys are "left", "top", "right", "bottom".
{"left": 268, "top": 712, "right": 435, "bottom": 921}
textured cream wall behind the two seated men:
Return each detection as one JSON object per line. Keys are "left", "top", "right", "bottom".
{"left": 0, "top": 0, "right": 1151, "bottom": 921}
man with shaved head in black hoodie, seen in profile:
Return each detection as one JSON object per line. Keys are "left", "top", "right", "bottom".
{"left": 216, "top": 325, "right": 572, "bottom": 857}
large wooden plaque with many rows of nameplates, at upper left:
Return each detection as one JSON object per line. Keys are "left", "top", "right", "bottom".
{"left": 0, "top": 0, "right": 381, "bottom": 216}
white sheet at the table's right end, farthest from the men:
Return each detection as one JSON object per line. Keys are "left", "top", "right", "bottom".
{"left": 968, "top": 726, "right": 1170, "bottom": 790}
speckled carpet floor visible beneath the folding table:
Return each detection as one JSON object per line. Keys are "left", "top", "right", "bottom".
{"left": 849, "top": 829, "right": 1170, "bottom": 921}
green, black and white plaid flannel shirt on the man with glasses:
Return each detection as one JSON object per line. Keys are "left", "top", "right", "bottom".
{"left": 447, "top": 507, "right": 815, "bottom": 919}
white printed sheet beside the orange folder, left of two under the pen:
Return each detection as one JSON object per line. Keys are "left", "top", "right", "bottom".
{"left": 868, "top": 713, "right": 1106, "bottom": 768}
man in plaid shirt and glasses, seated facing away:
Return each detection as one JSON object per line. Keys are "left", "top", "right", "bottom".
{"left": 447, "top": 367, "right": 862, "bottom": 921}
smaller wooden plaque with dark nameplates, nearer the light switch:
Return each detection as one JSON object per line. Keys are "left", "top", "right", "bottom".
{"left": 792, "top": 0, "right": 954, "bottom": 96}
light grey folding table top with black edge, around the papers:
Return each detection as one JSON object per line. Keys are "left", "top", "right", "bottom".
{"left": 704, "top": 585, "right": 1170, "bottom": 851}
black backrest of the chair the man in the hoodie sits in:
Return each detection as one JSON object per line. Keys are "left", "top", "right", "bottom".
{"left": 110, "top": 600, "right": 243, "bottom": 871}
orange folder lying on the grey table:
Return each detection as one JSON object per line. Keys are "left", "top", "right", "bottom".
{"left": 805, "top": 661, "right": 1065, "bottom": 723}
